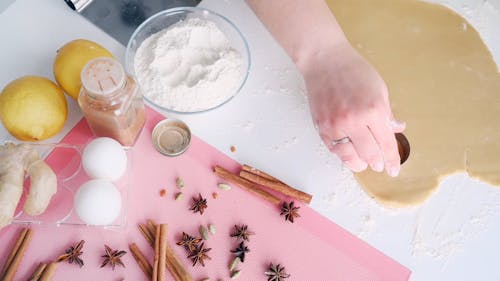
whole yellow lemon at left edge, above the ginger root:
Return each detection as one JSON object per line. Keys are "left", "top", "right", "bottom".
{"left": 0, "top": 76, "right": 68, "bottom": 141}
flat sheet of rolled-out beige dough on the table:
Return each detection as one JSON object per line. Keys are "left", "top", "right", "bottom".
{"left": 328, "top": 0, "right": 500, "bottom": 207}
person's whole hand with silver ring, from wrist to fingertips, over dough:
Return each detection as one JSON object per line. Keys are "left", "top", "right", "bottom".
{"left": 299, "top": 41, "right": 405, "bottom": 177}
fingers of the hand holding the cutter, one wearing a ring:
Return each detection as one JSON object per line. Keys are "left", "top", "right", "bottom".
{"left": 316, "top": 84, "right": 406, "bottom": 177}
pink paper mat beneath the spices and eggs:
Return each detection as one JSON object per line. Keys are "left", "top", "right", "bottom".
{"left": 0, "top": 106, "right": 410, "bottom": 281}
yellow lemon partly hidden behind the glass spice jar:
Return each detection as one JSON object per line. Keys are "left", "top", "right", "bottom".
{"left": 54, "top": 39, "right": 113, "bottom": 99}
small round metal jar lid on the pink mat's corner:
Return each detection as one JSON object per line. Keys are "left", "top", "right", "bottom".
{"left": 152, "top": 119, "right": 191, "bottom": 156}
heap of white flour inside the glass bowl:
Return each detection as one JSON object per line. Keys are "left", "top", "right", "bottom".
{"left": 134, "top": 18, "right": 245, "bottom": 112}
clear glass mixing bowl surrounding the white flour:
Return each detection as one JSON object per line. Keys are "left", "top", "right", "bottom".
{"left": 125, "top": 7, "right": 250, "bottom": 113}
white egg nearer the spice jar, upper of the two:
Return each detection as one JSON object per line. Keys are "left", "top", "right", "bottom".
{"left": 82, "top": 138, "right": 127, "bottom": 181}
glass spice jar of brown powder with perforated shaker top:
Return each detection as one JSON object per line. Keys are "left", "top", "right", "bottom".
{"left": 78, "top": 57, "right": 146, "bottom": 146}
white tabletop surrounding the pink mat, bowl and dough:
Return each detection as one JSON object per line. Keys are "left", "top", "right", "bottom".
{"left": 0, "top": 0, "right": 500, "bottom": 281}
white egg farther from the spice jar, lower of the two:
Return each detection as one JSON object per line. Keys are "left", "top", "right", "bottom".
{"left": 74, "top": 179, "right": 122, "bottom": 225}
